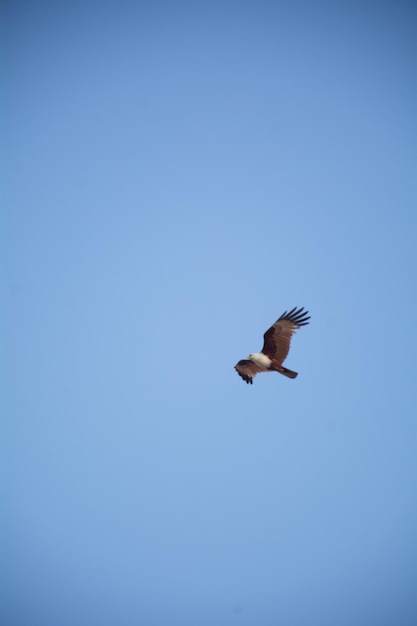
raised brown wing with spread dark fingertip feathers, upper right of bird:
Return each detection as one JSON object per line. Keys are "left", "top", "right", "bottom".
{"left": 262, "top": 307, "right": 310, "bottom": 365}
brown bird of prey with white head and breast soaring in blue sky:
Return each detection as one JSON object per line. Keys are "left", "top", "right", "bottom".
{"left": 235, "top": 307, "right": 310, "bottom": 385}
